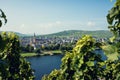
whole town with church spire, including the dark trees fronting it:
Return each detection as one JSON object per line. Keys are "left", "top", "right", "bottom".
{"left": 20, "top": 33, "right": 109, "bottom": 50}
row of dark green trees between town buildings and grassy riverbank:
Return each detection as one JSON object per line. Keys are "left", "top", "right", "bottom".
{"left": 20, "top": 43, "right": 75, "bottom": 53}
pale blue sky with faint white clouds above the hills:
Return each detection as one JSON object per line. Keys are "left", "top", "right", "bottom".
{"left": 0, "top": 0, "right": 114, "bottom": 35}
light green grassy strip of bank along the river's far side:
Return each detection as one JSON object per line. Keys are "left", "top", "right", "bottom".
{"left": 20, "top": 50, "right": 62, "bottom": 57}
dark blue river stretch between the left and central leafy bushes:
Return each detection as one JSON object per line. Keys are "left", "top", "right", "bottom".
{"left": 26, "top": 55, "right": 62, "bottom": 80}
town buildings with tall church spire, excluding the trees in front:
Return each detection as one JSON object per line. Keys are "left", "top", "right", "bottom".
{"left": 20, "top": 33, "right": 108, "bottom": 49}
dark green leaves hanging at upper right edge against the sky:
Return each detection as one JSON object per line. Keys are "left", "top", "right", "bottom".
{"left": 107, "top": 0, "right": 120, "bottom": 42}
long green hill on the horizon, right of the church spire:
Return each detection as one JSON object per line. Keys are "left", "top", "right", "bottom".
{"left": 42, "top": 30, "right": 112, "bottom": 38}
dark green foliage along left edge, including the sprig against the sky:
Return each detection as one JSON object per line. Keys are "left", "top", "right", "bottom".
{"left": 0, "top": 10, "right": 34, "bottom": 80}
